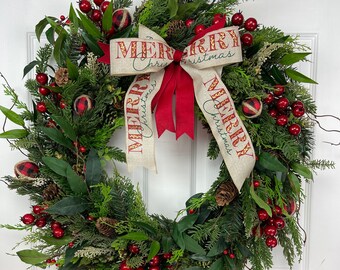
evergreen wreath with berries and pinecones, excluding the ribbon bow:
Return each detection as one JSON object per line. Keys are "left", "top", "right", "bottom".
{"left": 0, "top": 0, "right": 333, "bottom": 270}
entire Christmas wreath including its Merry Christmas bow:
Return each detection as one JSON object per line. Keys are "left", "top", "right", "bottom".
{"left": 0, "top": 0, "right": 333, "bottom": 270}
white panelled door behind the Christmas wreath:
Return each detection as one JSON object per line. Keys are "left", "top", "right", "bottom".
{"left": 0, "top": 0, "right": 340, "bottom": 270}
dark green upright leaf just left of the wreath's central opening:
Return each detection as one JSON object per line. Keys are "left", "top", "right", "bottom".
{"left": 85, "top": 149, "right": 103, "bottom": 186}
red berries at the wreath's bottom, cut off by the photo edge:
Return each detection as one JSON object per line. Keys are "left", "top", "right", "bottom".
{"left": 119, "top": 248, "right": 173, "bottom": 270}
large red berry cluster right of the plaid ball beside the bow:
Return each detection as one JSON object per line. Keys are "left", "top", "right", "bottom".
{"left": 263, "top": 84, "right": 305, "bottom": 136}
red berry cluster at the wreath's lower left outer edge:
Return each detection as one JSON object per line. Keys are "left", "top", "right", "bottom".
{"left": 21, "top": 205, "right": 65, "bottom": 239}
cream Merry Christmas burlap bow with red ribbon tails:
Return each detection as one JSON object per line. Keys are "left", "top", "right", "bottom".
{"left": 102, "top": 21, "right": 255, "bottom": 190}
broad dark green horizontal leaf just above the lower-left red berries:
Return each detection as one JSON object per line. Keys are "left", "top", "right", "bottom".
{"left": 45, "top": 197, "right": 91, "bottom": 216}
